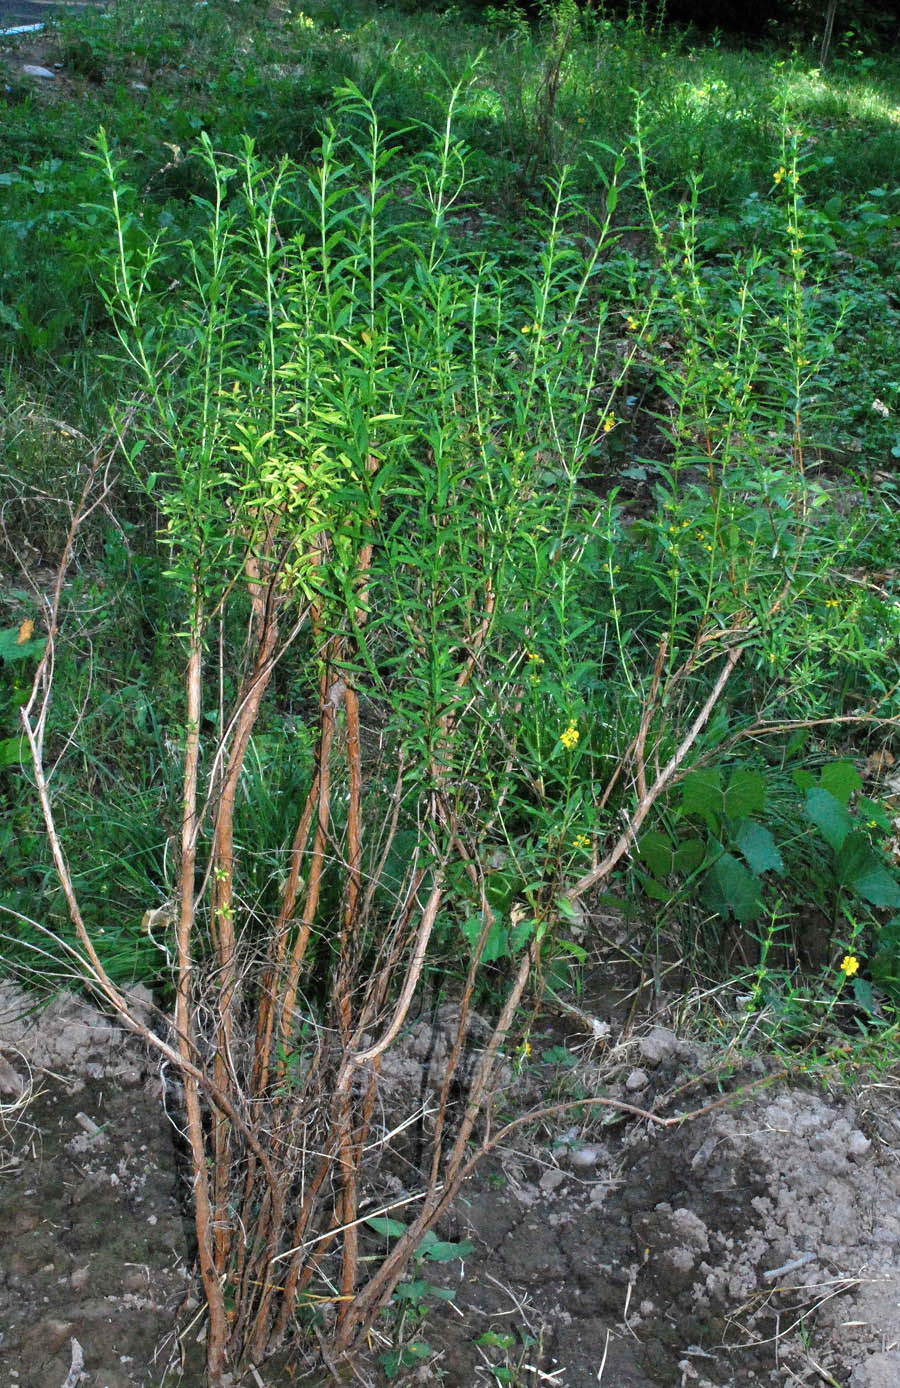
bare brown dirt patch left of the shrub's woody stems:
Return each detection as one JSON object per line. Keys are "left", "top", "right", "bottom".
{"left": 0, "top": 985, "right": 189, "bottom": 1388}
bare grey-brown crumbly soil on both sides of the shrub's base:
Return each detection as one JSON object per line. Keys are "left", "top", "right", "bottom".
{"left": 0, "top": 984, "right": 900, "bottom": 1388}
